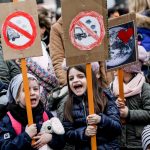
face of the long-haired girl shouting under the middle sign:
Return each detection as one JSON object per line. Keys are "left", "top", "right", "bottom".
{"left": 69, "top": 68, "right": 87, "bottom": 96}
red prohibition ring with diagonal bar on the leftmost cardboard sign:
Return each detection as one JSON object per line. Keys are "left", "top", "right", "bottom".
{"left": 2, "top": 11, "right": 37, "bottom": 50}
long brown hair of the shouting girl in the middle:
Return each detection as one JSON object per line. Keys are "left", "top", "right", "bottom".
{"left": 64, "top": 65, "right": 107, "bottom": 122}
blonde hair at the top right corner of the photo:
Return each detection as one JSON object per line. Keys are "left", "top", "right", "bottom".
{"left": 128, "top": 0, "right": 150, "bottom": 12}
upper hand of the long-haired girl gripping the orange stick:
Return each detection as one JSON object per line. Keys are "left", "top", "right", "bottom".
{"left": 87, "top": 114, "right": 101, "bottom": 125}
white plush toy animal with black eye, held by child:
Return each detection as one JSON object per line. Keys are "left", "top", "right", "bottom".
{"left": 39, "top": 117, "right": 65, "bottom": 150}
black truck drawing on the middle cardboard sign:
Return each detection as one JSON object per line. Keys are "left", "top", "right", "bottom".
{"left": 74, "top": 27, "right": 87, "bottom": 41}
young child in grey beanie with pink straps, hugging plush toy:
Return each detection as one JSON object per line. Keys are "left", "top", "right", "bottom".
{"left": 0, "top": 74, "right": 64, "bottom": 150}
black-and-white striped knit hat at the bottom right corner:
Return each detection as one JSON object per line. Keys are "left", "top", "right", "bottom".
{"left": 142, "top": 125, "right": 150, "bottom": 150}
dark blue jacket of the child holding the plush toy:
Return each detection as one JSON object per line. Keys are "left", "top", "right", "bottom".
{"left": 0, "top": 110, "right": 64, "bottom": 150}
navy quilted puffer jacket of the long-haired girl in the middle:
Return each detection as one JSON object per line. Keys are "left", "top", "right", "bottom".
{"left": 63, "top": 90, "right": 122, "bottom": 150}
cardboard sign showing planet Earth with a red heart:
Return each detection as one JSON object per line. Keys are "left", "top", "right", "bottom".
{"left": 106, "top": 13, "right": 137, "bottom": 71}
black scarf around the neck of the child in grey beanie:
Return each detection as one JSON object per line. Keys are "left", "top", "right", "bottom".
{"left": 7, "top": 101, "right": 44, "bottom": 127}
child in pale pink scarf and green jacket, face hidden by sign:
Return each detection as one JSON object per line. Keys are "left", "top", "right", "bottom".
{"left": 111, "top": 46, "right": 150, "bottom": 150}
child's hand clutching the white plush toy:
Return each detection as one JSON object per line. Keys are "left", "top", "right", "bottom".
{"left": 32, "top": 133, "right": 52, "bottom": 149}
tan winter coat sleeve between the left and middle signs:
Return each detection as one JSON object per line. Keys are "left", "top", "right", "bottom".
{"left": 50, "top": 18, "right": 67, "bottom": 85}
